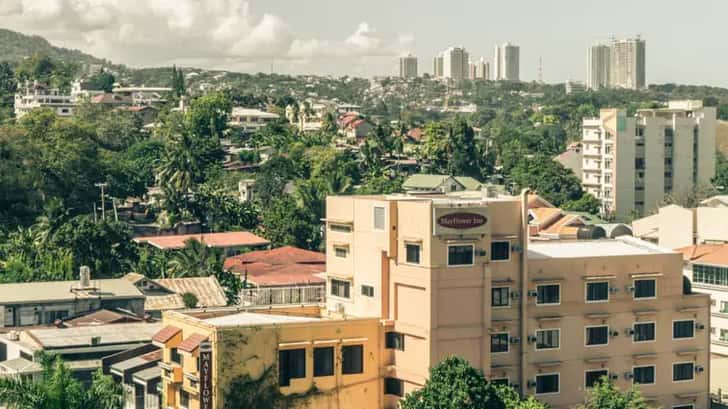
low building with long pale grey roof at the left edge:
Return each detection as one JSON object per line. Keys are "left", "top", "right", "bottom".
{"left": 0, "top": 267, "right": 144, "bottom": 330}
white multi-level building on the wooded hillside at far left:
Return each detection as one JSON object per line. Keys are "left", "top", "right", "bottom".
{"left": 15, "top": 81, "right": 76, "bottom": 118}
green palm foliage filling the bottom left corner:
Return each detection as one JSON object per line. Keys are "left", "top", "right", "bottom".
{"left": 0, "top": 356, "right": 124, "bottom": 409}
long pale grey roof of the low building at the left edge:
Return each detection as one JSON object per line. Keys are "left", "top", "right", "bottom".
{"left": 0, "top": 278, "right": 144, "bottom": 304}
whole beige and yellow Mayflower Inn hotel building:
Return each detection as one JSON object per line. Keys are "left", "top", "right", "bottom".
{"left": 155, "top": 192, "right": 710, "bottom": 409}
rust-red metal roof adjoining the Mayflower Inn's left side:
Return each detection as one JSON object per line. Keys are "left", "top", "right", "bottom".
{"left": 225, "top": 246, "right": 326, "bottom": 286}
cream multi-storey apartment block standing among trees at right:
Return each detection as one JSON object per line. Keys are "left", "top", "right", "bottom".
{"left": 582, "top": 101, "right": 716, "bottom": 220}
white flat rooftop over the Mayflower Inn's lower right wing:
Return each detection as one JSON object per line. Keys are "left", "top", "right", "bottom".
{"left": 528, "top": 237, "right": 674, "bottom": 260}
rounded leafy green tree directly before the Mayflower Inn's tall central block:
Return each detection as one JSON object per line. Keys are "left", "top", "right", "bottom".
{"left": 400, "top": 356, "right": 506, "bottom": 409}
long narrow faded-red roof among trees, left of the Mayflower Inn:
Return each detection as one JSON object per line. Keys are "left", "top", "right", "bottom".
{"left": 134, "top": 231, "right": 270, "bottom": 250}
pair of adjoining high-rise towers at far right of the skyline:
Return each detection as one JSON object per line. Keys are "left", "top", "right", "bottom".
{"left": 586, "top": 36, "right": 646, "bottom": 90}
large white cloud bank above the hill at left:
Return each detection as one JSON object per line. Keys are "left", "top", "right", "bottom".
{"left": 0, "top": 0, "right": 413, "bottom": 74}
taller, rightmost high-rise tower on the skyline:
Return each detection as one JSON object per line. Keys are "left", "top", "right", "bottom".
{"left": 609, "top": 37, "right": 646, "bottom": 89}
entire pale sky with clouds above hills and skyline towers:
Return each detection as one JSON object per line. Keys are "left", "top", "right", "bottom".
{"left": 0, "top": 0, "right": 728, "bottom": 87}
